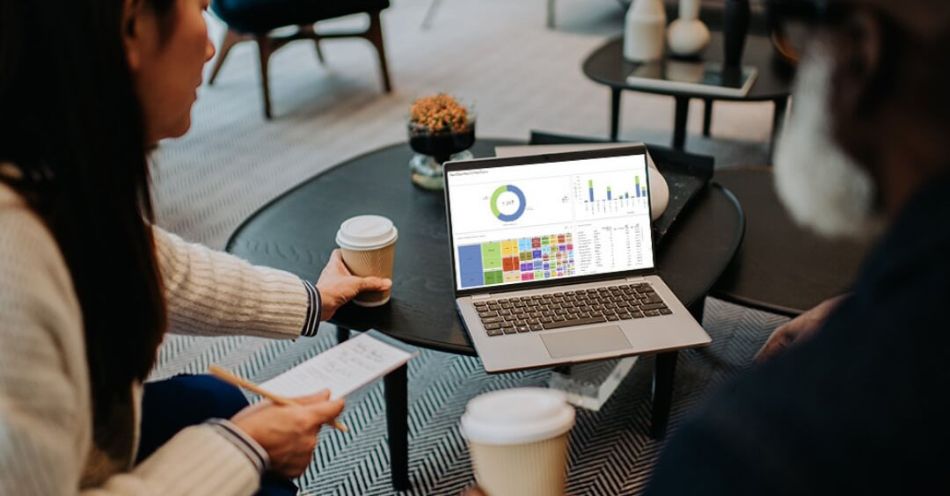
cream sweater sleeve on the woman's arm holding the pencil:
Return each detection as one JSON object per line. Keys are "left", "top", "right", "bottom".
{"left": 0, "top": 201, "right": 260, "bottom": 496}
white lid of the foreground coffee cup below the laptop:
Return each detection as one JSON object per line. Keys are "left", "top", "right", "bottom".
{"left": 461, "top": 388, "right": 574, "bottom": 445}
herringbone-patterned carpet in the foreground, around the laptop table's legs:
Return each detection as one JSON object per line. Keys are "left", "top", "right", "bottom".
{"left": 154, "top": 299, "right": 785, "bottom": 495}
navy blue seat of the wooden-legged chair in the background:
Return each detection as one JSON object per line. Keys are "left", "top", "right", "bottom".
{"left": 211, "top": 0, "right": 389, "bottom": 33}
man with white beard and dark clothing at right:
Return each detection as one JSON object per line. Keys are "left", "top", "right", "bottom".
{"left": 647, "top": 0, "right": 950, "bottom": 495}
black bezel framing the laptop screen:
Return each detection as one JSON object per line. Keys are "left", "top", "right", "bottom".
{"left": 442, "top": 144, "right": 656, "bottom": 297}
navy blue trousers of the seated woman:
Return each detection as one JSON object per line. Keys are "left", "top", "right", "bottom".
{"left": 136, "top": 375, "right": 297, "bottom": 496}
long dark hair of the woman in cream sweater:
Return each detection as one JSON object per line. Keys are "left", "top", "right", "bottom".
{"left": 0, "top": 0, "right": 174, "bottom": 450}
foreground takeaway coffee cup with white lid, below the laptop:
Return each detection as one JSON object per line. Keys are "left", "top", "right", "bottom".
{"left": 461, "top": 388, "right": 574, "bottom": 496}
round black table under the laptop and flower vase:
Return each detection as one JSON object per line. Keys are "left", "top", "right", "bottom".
{"left": 227, "top": 139, "right": 745, "bottom": 490}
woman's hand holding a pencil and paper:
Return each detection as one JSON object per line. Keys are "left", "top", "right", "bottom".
{"left": 231, "top": 391, "right": 343, "bottom": 478}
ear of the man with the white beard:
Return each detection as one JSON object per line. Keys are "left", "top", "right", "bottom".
{"left": 831, "top": 11, "right": 884, "bottom": 117}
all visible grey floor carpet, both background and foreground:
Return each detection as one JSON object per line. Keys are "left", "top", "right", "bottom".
{"left": 154, "top": 0, "right": 784, "bottom": 495}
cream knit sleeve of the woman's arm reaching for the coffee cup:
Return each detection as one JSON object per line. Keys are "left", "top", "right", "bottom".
{"left": 153, "top": 227, "right": 320, "bottom": 338}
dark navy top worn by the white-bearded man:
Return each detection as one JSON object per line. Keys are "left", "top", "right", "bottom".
{"left": 647, "top": 170, "right": 950, "bottom": 495}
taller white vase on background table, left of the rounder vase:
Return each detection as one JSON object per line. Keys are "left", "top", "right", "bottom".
{"left": 623, "top": 0, "right": 666, "bottom": 62}
